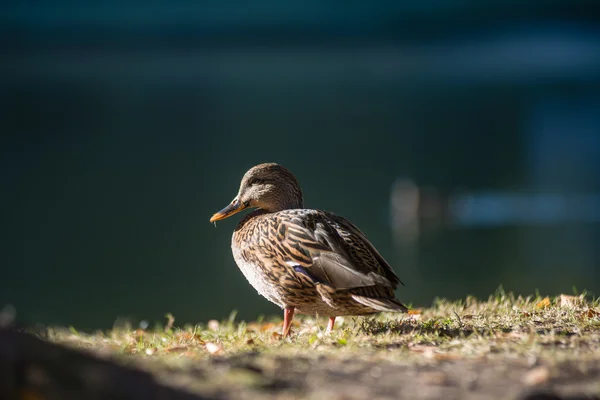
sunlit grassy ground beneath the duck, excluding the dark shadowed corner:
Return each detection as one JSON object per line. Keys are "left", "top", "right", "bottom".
{"left": 41, "top": 290, "right": 600, "bottom": 398}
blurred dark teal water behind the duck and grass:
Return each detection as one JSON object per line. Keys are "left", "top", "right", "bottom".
{"left": 0, "top": 0, "right": 600, "bottom": 329}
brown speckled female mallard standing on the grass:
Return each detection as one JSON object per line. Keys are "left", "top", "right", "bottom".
{"left": 210, "top": 163, "right": 407, "bottom": 336}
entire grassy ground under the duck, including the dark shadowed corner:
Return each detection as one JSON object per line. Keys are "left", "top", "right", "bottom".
{"left": 0, "top": 295, "right": 600, "bottom": 400}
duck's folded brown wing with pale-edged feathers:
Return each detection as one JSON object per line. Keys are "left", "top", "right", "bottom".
{"left": 276, "top": 210, "right": 400, "bottom": 297}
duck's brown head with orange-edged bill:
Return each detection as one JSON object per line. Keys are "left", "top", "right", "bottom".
{"left": 210, "top": 163, "right": 303, "bottom": 222}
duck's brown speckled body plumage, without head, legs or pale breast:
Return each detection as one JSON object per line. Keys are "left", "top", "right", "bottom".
{"left": 232, "top": 209, "right": 406, "bottom": 315}
